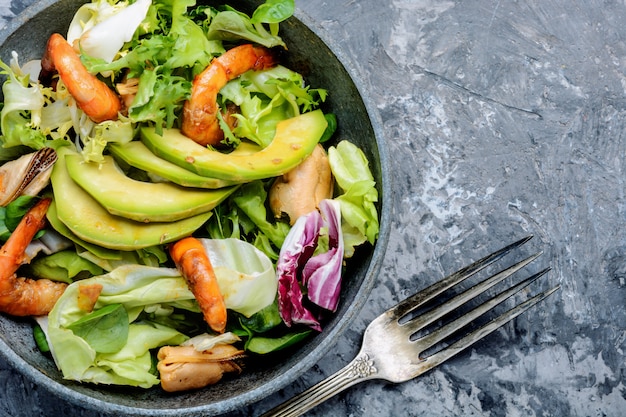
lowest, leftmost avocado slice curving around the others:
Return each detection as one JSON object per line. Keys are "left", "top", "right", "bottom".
{"left": 50, "top": 147, "right": 212, "bottom": 250}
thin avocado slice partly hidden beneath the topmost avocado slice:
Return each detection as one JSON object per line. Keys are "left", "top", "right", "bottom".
{"left": 109, "top": 141, "right": 234, "bottom": 188}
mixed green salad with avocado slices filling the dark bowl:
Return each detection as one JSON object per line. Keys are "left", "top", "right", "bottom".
{"left": 0, "top": 0, "right": 378, "bottom": 390}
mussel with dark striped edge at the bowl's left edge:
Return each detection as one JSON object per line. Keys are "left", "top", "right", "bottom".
{"left": 0, "top": 148, "right": 57, "bottom": 207}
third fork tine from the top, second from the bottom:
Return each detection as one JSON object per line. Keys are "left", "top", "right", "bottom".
{"left": 416, "top": 267, "right": 551, "bottom": 352}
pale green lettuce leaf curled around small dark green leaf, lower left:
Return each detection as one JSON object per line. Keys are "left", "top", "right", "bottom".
{"left": 48, "top": 265, "right": 198, "bottom": 388}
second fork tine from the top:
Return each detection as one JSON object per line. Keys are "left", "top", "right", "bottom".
{"left": 400, "top": 252, "right": 542, "bottom": 335}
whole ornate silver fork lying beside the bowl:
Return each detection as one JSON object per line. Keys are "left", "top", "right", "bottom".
{"left": 261, "top": 236, "right": 559, "bottom": 417}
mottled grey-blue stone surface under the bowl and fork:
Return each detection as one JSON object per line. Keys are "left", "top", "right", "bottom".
{"left": 0, "top": 0, "right": 626, "bottom": 417}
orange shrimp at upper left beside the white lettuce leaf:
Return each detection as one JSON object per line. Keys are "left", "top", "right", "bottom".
{"left": 41, "top": 33, "right": 122, "bottom": 123}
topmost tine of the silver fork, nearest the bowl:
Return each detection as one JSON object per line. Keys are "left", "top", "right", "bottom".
{"left": 389, "top": 235, "right": 533, "bottom": 318}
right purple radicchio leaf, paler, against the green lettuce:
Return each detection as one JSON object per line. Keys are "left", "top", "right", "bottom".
{"left": 302, "top": 200, "right": 343, "bottom": 312}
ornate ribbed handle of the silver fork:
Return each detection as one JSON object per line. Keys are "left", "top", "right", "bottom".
{"left": 261, "top": 353, "right": 377, "bottom": 417}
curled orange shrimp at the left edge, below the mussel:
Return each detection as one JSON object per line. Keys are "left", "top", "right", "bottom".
{"left": 0, "top": 198, "right": 67, "bottom": 316}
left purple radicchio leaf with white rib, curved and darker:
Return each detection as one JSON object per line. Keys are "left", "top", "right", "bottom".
{"left": 276, "top": 210, "right": 322, "bottom": 331}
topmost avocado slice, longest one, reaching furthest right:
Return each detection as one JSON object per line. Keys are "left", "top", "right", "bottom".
{"left": 141, "top": 110, "right": 327, "bottom": 182}
